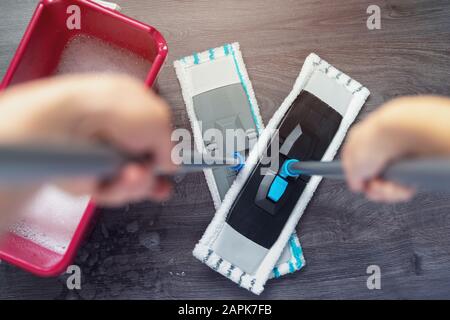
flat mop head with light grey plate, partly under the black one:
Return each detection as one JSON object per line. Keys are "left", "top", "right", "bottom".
{"left": 174, "top": 43, "right": 305, "bottom": 278}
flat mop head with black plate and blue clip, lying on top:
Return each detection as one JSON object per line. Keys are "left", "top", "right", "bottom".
{"left": 194, "top": 54, "right": 369, "bottom": 294}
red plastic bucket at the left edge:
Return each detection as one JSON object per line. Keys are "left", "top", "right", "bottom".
{"left": 0, "top": 0, "right": 167, "bottom": 276}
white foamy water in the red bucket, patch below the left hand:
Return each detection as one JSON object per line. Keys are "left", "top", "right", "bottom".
{"left": 11, "top": 185, "right": 89, "bottom": 254}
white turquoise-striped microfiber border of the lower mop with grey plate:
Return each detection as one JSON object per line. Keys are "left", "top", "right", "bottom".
{"left": 174, "top": 42, "right": 305, "bottom": 278}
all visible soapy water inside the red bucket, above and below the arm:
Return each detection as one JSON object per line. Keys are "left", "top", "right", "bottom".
{"left": 10, "top": 35, "right": 151, "bottom": 254}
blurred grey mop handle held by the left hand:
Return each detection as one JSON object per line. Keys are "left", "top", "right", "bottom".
{"left": 0, "top": 143, "right": 238, "bottom": 185}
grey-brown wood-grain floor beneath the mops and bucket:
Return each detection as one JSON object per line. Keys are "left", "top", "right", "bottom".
{"left": 0, "top": 0, "right": 450, "bottom": 299}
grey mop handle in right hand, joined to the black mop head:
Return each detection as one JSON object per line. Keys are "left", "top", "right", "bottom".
{"left": 287, "top": 158, "right": 450, "bottom": 191}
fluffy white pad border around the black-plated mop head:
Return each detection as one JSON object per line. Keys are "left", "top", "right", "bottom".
{"left": 193, "top": 53, "right": 370, "bottom": 294}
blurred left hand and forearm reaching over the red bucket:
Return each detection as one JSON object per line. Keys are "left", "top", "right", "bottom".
{"left": 0, "top": 75, "right": 175, "bottom": 206}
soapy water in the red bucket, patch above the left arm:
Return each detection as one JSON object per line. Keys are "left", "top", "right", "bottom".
{"left": 55, "top": 35, "right": 151, "bottom": 81}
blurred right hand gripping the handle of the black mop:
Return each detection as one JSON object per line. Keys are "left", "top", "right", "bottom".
{"left": 342, "top": 96, "right": 450, "bottom": 202}
